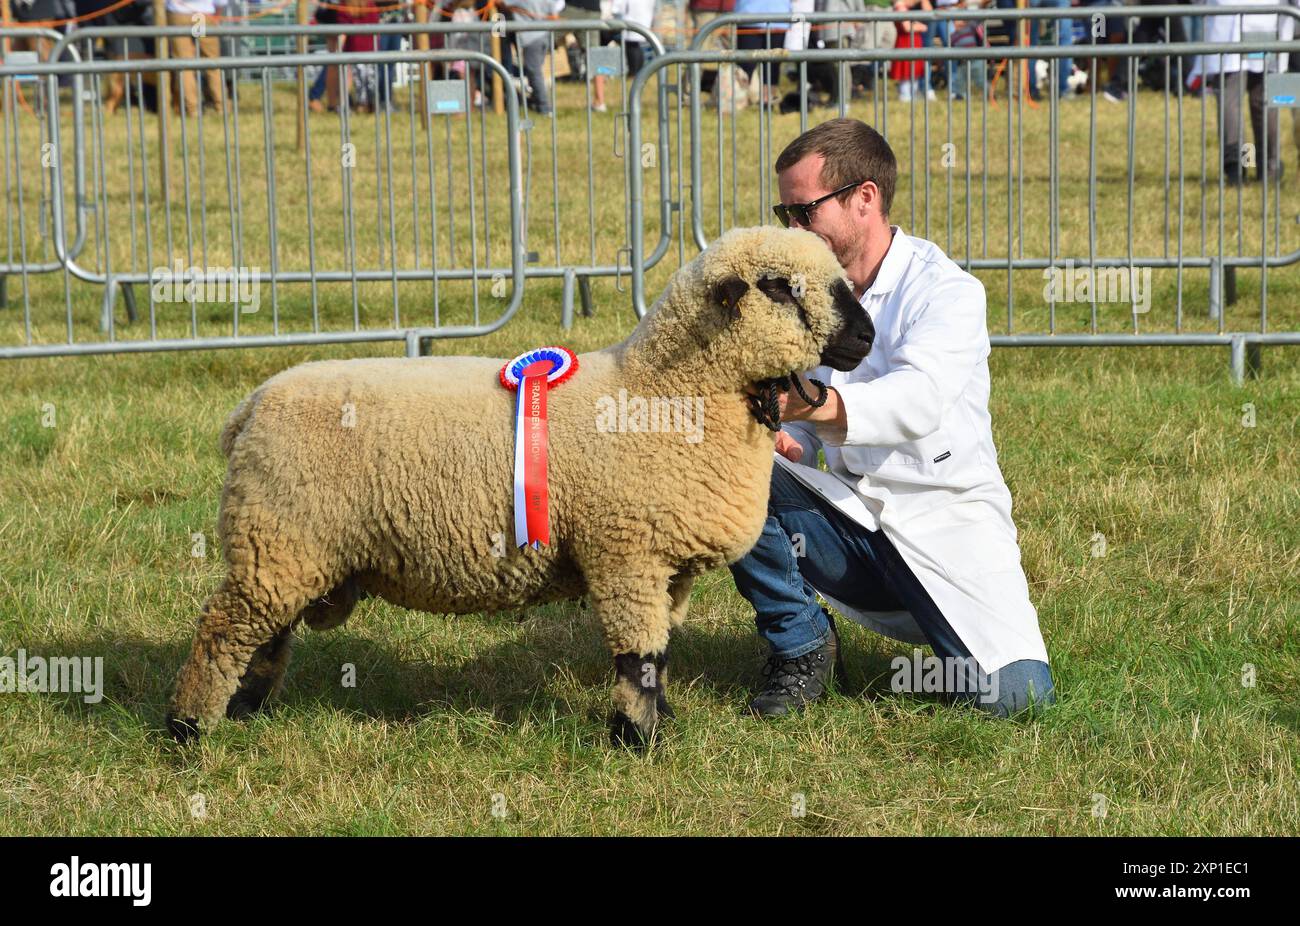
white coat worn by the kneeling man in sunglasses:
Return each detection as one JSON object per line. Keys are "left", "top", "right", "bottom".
{"left": 777, "top": 226, "right": 1048, "bottom": 672}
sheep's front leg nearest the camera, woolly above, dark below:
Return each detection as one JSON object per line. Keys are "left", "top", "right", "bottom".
{"left": 588, "top": 568, "right": 672, "bottom": 748}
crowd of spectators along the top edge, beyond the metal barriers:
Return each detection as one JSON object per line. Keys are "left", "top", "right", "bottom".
{"left": 10, "top": 0, "right": 1300, "bottom": 182}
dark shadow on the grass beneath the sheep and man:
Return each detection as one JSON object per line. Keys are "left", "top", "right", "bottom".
{"left": 23, "top": 603, "right": 946, "bottom": 735}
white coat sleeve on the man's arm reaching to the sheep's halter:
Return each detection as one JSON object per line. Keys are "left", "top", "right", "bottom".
{"left": 819, "top": 274, "right": 989, "bottom": 447}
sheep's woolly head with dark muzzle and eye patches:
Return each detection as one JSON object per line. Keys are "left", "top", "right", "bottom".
{"left": 701, "top": 228, "right": 875, "bottom": 382}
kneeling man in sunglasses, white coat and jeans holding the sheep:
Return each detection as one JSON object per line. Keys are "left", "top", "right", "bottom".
{"left": 732, "top": 118, "right": 1053, "bottom": 717}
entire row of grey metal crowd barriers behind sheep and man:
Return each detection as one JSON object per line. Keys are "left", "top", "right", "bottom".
{"left": 0, "top": 7, "right": 1300, "bottom": 372}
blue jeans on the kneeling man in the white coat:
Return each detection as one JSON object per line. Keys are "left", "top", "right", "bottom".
{"left": 731, "top": 466, "right": 1056, "bottom": 717}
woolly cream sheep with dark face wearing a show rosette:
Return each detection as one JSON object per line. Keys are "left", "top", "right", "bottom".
{"left": 166, "top": 228, "right": 874, "bottom": 748}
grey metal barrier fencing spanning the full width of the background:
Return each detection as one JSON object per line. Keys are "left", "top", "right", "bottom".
{"left": 0, "top": 7, "right": 1300, "bottom": 375}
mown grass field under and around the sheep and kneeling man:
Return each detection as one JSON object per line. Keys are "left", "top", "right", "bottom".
{"left": 0, "top": 72, "right": 1300, "bottom": 835}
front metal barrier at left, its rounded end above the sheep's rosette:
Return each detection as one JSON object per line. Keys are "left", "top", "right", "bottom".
{"left": 0, "top": 46, "right": 524, "bottom": 358}
